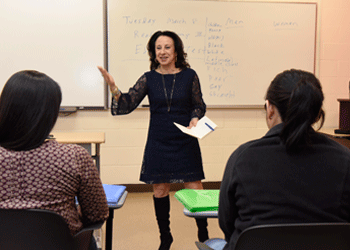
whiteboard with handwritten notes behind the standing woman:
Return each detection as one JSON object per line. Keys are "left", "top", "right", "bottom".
{"left": 108, "top": 0, "right": 317, "bottom": 107}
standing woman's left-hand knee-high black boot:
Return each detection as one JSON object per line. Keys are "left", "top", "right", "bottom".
{"left": 153, "top": 195, "right": 173, "bottom": 250}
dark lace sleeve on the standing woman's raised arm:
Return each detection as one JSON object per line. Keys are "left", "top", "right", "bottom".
{"left": 111, "top": 75, "right": 147, "bottom": 115}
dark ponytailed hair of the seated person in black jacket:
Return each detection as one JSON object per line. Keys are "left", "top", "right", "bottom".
{"left": 266, "top": 69, "right": 325, "bottom": 151}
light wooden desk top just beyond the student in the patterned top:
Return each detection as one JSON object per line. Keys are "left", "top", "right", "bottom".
{"left": 51, "top": 131, "right": 105, "bottom": 144}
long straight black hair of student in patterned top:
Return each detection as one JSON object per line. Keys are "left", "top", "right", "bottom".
{"left": 0, "top": 70, "right": 62, "bottom": 151}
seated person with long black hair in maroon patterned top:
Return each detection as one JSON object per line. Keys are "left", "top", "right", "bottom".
{"left": 0, "top": 71, "right": 108, "bottom": 248}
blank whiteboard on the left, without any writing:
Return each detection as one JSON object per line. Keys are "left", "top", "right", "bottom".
{"left": 0, "top": 0, "right": 107, "bottom": 109}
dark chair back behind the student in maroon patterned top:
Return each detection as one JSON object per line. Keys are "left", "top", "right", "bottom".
{"left": 0, "top": 209, "right": 93, "bottom": 250}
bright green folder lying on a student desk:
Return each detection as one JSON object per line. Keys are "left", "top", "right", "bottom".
{"left": 175, "top": 189, "right": 220, "bottom": 212}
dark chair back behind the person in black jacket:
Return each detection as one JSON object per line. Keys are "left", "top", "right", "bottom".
{"left": 234, "top": 223, "right": 350, "bottom": 250}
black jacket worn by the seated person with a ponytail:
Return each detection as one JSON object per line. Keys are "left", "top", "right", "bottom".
{"left": 219, "top": 124, "right": 350, "bottom": 249}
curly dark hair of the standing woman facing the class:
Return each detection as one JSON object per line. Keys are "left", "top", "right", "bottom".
{"left": 147, "top": 31, "right": 190, "bottom": 70}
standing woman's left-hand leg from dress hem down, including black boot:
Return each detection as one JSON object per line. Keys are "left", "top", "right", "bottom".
{"left": 153, "top": 183, "right": 173, "bottom": 250}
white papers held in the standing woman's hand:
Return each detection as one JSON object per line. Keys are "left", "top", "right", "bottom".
{"left": 174, "top": 116, "right": 217, "bottom": 139}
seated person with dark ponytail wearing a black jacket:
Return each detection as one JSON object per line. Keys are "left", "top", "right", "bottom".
{"left": 218, "top": 69, "right": 350, "bottom": 249}
